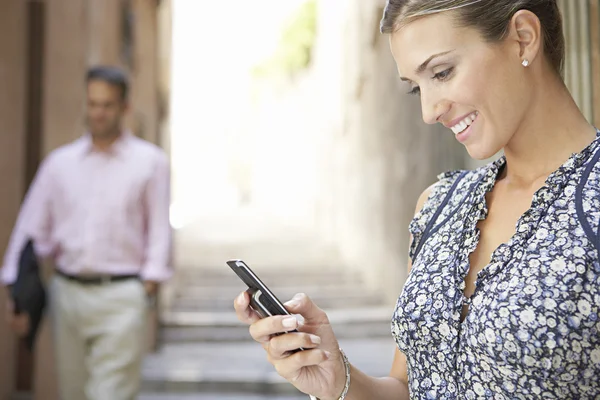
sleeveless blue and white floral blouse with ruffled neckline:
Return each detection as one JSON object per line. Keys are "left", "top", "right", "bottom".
{"left": 392, "top": 131, "right": 600, "bottom": 400}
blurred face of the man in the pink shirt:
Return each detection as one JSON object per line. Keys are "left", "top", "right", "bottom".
{"left": 86, "top": 80, "right": 127, "bottom": 138}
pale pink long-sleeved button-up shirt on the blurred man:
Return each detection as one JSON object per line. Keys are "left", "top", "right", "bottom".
{"left": 0, "top": 133, "right": 171, "bottom": 284}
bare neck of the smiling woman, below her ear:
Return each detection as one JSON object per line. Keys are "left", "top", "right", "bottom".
{"left": 504, "top": 74, "right": 596, "bottom": 186}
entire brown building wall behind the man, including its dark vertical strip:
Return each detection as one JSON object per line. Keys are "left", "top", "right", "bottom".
{"left": 0, "top": 0, "right": 165, "bottom": 400}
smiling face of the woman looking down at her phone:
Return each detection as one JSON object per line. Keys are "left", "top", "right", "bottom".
{"left": 390, "top": 13, "right": 532, "bottom": 160}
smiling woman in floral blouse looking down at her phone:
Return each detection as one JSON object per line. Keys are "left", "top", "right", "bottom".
{"left": 235, "top": 0, "right": 600, "bottom": 400}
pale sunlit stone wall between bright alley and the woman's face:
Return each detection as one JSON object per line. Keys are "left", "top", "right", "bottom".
{"left": 315, "top": 0, "right": 466, "bottom": 302}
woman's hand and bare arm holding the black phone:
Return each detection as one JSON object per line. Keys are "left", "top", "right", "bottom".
{"left": 234, "top": 188, "right": 431, "bottom": 400}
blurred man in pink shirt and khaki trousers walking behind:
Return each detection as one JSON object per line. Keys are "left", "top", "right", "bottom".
{"left": 0, "top": 66, "right": 172, "bottom": 400}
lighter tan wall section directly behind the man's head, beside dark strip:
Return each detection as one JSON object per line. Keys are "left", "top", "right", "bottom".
{"left": 44, "top": 0, "right": 159, "bottom": 154}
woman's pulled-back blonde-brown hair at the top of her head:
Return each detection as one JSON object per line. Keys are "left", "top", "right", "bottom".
{"left": 381, "top": 0, "right": 565, "bottom": 76}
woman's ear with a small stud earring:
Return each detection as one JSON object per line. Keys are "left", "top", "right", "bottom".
{"left": 509, "top": 10, "right": 543, "bottom": 63}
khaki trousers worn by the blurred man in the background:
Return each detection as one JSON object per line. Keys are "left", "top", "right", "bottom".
{"left": 50, "top": 276, "right": 147, "bottom": 400}
